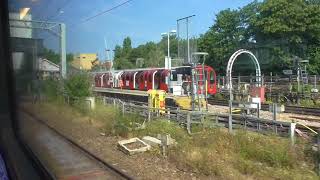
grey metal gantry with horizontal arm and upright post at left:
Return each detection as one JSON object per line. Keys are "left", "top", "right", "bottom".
{"left": 9, "top": 19, "right": 67, "bottom": 78}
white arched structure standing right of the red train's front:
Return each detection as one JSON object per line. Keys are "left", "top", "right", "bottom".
{"left": 227, "top": 49, "right": 261, "bottom": 91}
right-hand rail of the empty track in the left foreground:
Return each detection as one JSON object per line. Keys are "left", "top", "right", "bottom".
{"left": 22, "top": 109, "right": 134, "bottom": 179}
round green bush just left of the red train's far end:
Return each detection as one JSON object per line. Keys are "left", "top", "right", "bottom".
{"left": 64, "top": 73, "right": 91, "bottom": 98}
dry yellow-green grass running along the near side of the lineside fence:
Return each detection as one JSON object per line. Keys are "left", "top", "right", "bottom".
{"left": 28, "top": 100, "right": 318, "bottom": 179}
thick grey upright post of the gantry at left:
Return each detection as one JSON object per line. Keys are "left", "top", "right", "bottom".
{"left": 60, "top": 23, "right": 67, "bottom": 79}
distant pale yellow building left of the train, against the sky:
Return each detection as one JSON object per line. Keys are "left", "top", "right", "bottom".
{"left": 71, "top": 53, "right": 99, "bottom": 70}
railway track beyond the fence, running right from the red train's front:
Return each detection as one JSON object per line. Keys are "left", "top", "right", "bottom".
{"left": 208, "top": 99, "right": 320, "bottom": 116}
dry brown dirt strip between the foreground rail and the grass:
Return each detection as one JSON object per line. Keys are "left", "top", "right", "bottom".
{"left": 21, "top": 102, "right": 209, "bottom": 180}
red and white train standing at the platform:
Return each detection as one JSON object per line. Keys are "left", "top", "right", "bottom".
{"left": 94, "top": 65, "right": 217, "bottom": 95}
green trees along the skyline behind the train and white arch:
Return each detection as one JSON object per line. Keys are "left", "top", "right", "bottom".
{"left": 115, "top": 0, "right": 320, "bottom": 74}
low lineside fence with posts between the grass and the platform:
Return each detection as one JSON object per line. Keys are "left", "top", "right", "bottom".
{"left": 102, "top": 97, "right": 300, "bottom": 143}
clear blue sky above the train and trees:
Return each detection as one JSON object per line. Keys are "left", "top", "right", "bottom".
{"left": 11, "top": 0, "right": 252, "bottom": 57}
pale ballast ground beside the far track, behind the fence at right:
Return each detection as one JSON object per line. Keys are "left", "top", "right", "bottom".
{"left": 208, "top": 104, "right": 320, "bottom": 127}
